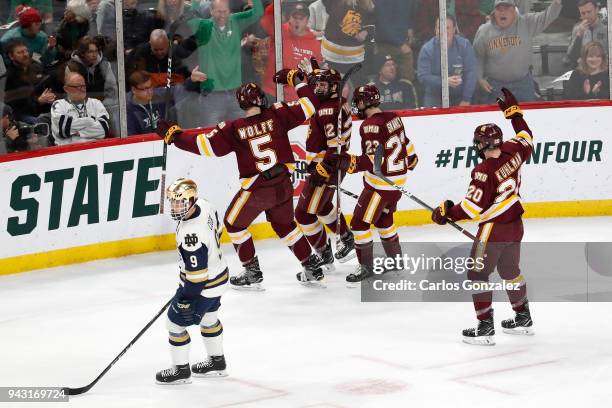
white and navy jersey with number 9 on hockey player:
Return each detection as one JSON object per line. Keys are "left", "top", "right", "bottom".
{"left": 176, "top": 199, "right": 229, "bottom": 299}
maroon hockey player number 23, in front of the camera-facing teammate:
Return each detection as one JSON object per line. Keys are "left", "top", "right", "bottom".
{"left": 329, "top": 85, "right": 418, "bottom": 283}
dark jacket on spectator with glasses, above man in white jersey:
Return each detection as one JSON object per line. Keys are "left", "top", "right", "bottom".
{"left": 67, "top": 52, "right": 117, "bottom": 100}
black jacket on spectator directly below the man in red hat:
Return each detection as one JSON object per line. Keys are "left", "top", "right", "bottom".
{"left": 4, "top": 61, "right": 51, "bottom": 117}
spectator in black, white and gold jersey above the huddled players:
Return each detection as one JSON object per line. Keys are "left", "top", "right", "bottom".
{"left": 321, "top": 0, "right": 374, "bottom": 84}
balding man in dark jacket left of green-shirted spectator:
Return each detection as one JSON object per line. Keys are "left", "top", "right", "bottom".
{"left": 125, "top": 28, "right": 190, "bottom": 88}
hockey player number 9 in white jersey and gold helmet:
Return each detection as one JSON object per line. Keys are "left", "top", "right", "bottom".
{"left": 156, "top": 178, "right": 229, "bottom": 384}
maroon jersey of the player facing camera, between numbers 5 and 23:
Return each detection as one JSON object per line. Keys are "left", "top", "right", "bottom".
{"left": 306, "top": 98, "right": 353, "bottom": 164}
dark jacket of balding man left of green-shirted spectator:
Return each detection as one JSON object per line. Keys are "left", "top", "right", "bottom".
{"left": 125, "top": 42, "right": 191, "bottom": 88}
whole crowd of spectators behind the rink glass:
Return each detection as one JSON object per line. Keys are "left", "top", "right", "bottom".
{"left": 0, "top": 0, "right": 610, "bottom": 153}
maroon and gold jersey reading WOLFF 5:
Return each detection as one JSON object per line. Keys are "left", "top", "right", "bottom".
{"left": 197, "top": 84, "right": 317, "bottom": 190}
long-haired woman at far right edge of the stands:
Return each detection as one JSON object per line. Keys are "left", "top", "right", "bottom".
{"left": 564, "top": 41, "right": 610, "bottom": 100}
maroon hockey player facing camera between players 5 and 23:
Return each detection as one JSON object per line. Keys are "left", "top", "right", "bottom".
{"left": 295, "top": 67, "right": 355, "bottom": 269}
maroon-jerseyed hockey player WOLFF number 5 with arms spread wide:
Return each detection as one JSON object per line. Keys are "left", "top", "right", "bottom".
{"left": 158, "top": 69, "right": 323, "bottom": 290}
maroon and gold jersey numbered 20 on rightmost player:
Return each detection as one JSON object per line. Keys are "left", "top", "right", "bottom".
{"left": 449, "top": 118, "right": 533, "bottom": 228}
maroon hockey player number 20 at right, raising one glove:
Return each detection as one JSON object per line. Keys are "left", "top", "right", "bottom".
{"left": 432, "top": 88, "right": 533, "bottom": 345}
